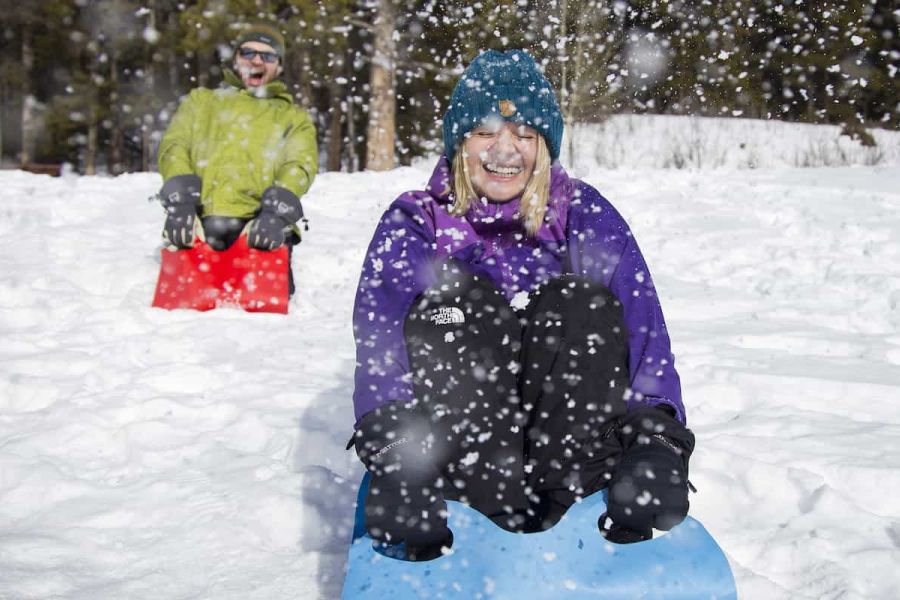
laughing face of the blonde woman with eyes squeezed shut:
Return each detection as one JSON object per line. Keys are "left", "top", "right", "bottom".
{"left": 462, "top": 120, "right": 539, "bottom": 202}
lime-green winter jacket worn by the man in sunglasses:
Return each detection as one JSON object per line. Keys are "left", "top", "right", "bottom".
{"left": 158, "top": 70, "right": 318, "bottom": 219}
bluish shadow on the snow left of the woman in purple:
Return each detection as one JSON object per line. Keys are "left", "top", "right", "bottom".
{"left": 293, "top": 361, "right": 363, "bottom": 598}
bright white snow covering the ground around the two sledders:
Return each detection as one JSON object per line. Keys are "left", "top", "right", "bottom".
{"left": 0, "top": 117, "right": 900, "bottom": 600}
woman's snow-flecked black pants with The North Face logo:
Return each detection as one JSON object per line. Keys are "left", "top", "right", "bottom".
{"left": 404, "top": 261, "right": 629, "bottom": 531}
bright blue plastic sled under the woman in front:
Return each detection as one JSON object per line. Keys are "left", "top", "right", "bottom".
{"left": 341, "top": 475, "right": 737, "bottom": 600}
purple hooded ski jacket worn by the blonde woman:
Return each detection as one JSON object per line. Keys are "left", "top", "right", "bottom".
{"left": 353, "top": 157, "right": 685, "bottom": 423}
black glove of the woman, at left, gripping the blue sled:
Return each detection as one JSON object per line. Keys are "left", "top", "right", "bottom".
{"left": 354, "top": 403, "right": 453, "bottom": 560}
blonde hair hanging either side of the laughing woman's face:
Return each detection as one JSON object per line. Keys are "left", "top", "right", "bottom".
{"left": 452, "top": 135, "right": 551, "bottom": 236}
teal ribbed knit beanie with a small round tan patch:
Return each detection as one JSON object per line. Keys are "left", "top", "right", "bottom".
{"left": 444, "top": 50, "right": 563, "bottom": 162}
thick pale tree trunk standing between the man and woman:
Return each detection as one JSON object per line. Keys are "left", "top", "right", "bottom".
{"left": 366, "top": 0, "right": 397, "bottom": 171}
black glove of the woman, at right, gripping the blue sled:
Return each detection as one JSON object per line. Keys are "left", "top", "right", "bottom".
{"left": 600, "top": 408, "right": 694, "bottom": 543}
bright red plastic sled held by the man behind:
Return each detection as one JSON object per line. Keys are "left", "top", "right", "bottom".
{"left": 153, "top": 235, "right": 288, "bottom": 314}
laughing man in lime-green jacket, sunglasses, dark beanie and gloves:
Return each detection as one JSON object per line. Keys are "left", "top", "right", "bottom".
{"left": 158, "top": 24, "right": 318, "bottom": 274}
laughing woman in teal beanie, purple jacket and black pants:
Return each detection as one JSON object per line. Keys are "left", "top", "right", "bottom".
{"left": 353, "top": 50, "right": 694, "bottom": 560}
